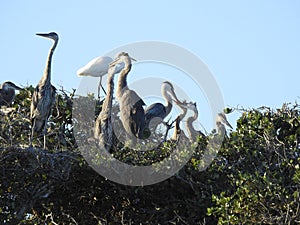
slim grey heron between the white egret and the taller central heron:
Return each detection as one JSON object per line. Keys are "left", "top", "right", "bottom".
{"left": 94, "top": 62, "right": 116, "bottom": 150}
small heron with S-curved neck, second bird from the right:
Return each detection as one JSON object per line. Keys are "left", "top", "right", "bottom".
{"left": 179, "top": 102, "right": 205, "bottom": 141}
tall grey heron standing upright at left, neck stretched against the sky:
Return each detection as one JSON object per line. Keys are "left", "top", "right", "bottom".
{"left": 30, "top": 32, "right": 58, "bottom": 148}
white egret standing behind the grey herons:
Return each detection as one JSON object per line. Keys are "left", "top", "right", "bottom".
{"left": 77, "top": 56, "right": 124, "bottom": 98}
